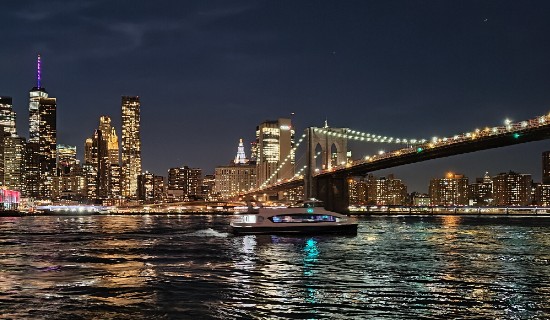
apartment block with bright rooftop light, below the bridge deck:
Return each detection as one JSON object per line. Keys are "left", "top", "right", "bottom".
{"left": 429, "top": 172, "right": 468, "bottom": 206}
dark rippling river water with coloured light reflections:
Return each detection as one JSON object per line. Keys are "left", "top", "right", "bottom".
{"left": 0, "top": 215, "right": 550, "bottom": 320}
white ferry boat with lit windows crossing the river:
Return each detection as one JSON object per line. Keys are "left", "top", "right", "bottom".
{"left": 230, "top": 199, "right": 357, "bottom": 235}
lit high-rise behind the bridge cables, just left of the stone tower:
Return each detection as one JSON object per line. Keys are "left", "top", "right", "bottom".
{"left": 255, "top": 118, "right": 294, "bottom": 186}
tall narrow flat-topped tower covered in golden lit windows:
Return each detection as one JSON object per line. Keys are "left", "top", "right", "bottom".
{"left": 121, "top": 96, "right": 141, "bottom": 199}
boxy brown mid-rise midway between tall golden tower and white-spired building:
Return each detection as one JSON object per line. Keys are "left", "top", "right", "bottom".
{"left": 167, "top": 166, "right": 202, "bottom": 201}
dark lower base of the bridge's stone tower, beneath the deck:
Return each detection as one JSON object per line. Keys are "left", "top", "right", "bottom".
{"left": 313, "top": 175, "right": 349, "bottom": 213}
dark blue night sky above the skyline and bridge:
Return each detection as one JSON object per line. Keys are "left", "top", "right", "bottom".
{"left": 0, "top": 0, "right": 550, "bottom": 191}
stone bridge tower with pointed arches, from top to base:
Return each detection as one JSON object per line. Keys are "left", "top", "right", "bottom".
{"left": 304, "top": 122, "right": 349, "bottom": 211}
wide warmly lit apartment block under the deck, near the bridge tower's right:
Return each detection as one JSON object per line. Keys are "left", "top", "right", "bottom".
{"left": 366, "top": 174, "right": 407, "bottom": 205}
